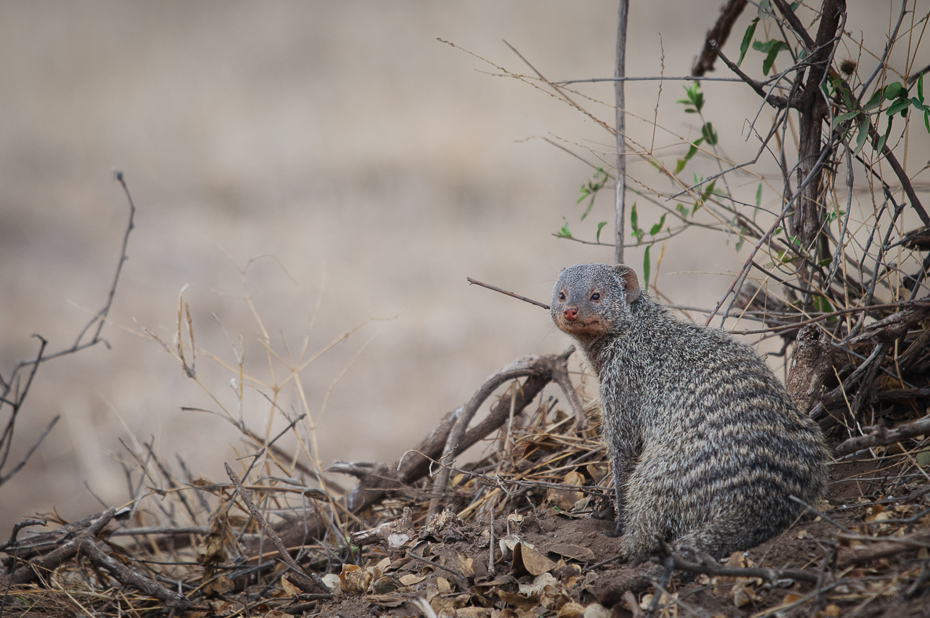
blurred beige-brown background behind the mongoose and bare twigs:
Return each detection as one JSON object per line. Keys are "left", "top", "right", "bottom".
{"left": 0, "top": 0, "right": 927, "bottom": 539}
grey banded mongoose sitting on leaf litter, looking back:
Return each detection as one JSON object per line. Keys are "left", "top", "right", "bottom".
{"left": 551, "top": 264, "right": 829, "bottom": 561}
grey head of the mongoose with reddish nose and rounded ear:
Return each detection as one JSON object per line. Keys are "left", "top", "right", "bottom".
{"left": 550, "top": 264, "right": 641, "bottom": 339}
